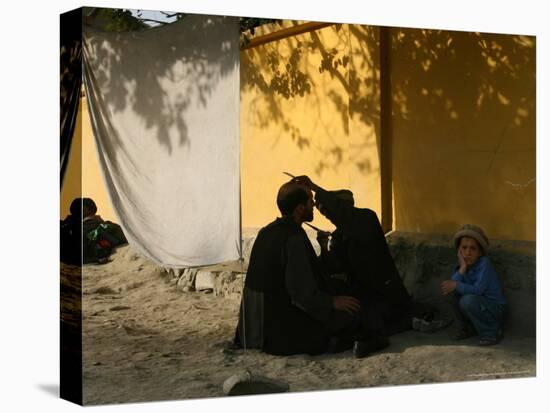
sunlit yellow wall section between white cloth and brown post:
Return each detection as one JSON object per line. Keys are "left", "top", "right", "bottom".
{"left": 240, "top": 21, "right": 380, "bottom": 228}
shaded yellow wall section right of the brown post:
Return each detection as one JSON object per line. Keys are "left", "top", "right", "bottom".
{"left": 391, "top": 29, "right": 536, "bottom": 240}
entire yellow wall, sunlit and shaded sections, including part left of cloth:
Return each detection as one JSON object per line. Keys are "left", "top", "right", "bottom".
{"left": 61, "top": 21, "right": 536, "bottom": 240}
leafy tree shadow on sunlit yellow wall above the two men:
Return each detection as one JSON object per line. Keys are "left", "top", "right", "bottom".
{"left": 241, "top": 22, "right": 380, "bottom": 175}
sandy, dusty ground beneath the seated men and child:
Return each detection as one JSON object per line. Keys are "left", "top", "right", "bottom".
{"left": 70, "top": 247, "right": 536, "bottom": 404}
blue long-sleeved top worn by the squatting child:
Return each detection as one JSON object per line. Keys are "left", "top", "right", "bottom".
{"left": 451, "top": 256, "right": 506, "bottom": 304}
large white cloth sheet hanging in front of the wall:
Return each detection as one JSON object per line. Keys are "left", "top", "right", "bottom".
{"left": 83, "top": 15, "right": 241, "bottom": 268}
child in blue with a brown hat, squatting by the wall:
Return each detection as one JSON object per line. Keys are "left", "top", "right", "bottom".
{"left": 441, "top": 224, "right": 506, "bottom": 346}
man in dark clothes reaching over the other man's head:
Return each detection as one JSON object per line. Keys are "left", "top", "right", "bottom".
{"left": 295, "top": 176, "right": 417, "bottom": 335}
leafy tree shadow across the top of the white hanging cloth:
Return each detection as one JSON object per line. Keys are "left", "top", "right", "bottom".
{"left": 85, "top": 15, "right": 239, "bottom": 163}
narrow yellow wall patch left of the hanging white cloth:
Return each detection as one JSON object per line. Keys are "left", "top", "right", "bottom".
{"left": 61, "top": 98, "right": 118, "bottom": 222}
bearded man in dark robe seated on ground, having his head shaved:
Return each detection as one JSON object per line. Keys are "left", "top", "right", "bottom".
{"left": 235, "top": 182, "right": 387, "bottom": 357}
